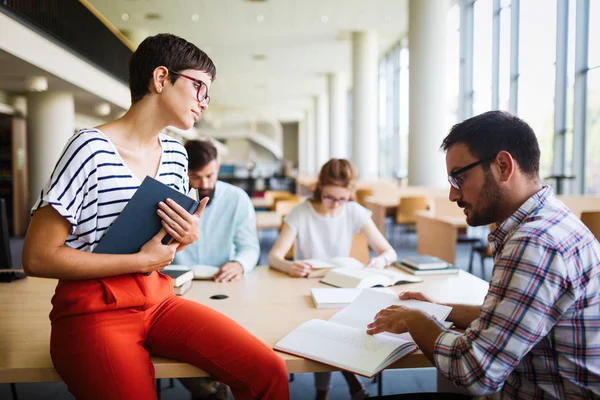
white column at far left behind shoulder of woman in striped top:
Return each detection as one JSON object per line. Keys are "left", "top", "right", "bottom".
{"left": 27, "top": 92, "right": 75, "bottom": 206}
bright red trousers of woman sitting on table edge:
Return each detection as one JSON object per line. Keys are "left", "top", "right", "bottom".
{"left": 50, "top": 272, "right": 289, "bottom": 400}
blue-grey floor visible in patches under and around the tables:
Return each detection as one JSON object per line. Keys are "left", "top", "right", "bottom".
{"left": 0, "top": 220, "right": 492, "bottom": 400}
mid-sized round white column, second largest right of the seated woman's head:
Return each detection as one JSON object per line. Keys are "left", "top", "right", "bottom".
{"left": 352, "top": 31, "right": 378, "bottom": 179}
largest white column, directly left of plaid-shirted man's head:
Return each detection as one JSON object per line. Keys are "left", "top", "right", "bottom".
{"left": 408, "top": 0, "right": 450, "bottom": 187}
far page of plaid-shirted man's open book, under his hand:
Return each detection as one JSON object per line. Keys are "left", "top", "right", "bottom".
{"left": 329, "top": 289, "right": 452, "bottom": 340}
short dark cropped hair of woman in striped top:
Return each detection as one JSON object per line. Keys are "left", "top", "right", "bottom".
{"left": 129, "top": 33, "right": 217, "bottom": 104}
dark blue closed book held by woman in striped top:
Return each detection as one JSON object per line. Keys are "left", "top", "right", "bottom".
{"left": 94, "top": 176, "right": 200, "bottom": 254}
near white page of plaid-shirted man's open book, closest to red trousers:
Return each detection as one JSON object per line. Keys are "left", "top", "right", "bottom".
{"left": 275, "top": 319, "right": 414, "bottom": 376}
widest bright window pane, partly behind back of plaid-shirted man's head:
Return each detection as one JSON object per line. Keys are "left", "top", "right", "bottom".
{"left": 518, "top": 0, "right": 556, "bottom": 184}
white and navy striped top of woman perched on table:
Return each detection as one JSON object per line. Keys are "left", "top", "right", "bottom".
{"left": 31, "top": 129, "right": 188, "bottom": 252}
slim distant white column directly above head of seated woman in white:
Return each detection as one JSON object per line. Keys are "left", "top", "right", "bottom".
{"left": 328, "top": 72, "right": 348, "bottom": 158}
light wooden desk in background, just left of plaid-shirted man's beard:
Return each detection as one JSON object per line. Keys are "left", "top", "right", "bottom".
{"left": 416, "top": 211, "right": 468, "bottom": 264}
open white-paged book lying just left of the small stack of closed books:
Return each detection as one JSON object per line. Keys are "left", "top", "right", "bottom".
{"left": 321, "top": 267, "right": 423, "bottom": 288}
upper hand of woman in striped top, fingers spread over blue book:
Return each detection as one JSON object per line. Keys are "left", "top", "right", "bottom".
{"left": 157, "top": 197, "right": 209, "bottom": 250}
